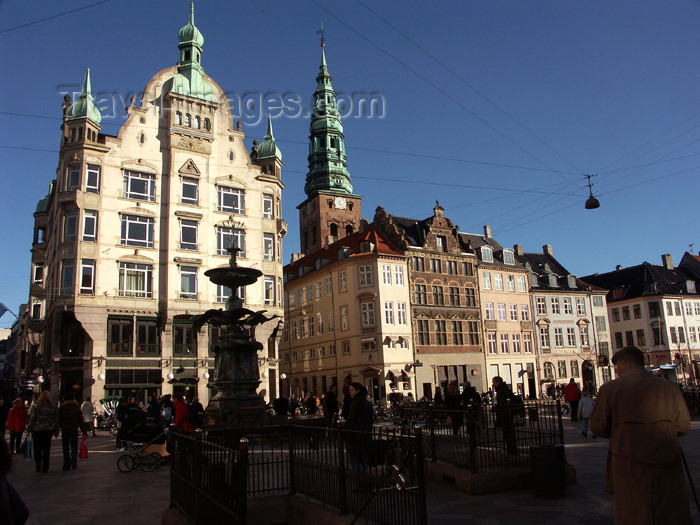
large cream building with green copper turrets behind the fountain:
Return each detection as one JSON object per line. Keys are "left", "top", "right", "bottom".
{"left": 26, "top": 7, "right": 286, "bottom": 400}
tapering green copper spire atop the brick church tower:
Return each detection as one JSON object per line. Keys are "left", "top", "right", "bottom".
{"left": 304, "top": 44, "right": 352, "bottom": 197}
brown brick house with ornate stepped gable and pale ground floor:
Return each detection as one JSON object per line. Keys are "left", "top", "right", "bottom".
{"left": 374, "top": 204, "right": 488, "bottom": 399}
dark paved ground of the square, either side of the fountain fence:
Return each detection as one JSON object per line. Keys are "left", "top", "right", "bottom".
{"left": 9, "top": 419, "right": 700, "bottom": 525}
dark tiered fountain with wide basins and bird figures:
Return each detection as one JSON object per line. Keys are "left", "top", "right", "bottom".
{"left": 192, "top": 247, "right": 278, "bottom": 427}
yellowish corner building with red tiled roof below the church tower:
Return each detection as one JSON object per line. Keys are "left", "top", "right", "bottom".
{"left": 280, "top": 222, "right": 415, "bottom": 402}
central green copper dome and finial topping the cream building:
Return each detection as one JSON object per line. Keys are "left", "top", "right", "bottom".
{"left": 163, "top": 2, "right": 216, "bottom": 102}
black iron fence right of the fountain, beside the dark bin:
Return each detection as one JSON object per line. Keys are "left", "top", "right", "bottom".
{"left": 402, "top": 401, "right": 564, "bottom": 472}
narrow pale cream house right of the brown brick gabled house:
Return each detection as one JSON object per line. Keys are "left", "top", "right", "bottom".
{"left": 459, "top": 226, "right": 538, "bottom": 398}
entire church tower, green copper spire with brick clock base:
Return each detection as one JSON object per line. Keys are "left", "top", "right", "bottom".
{"left": 297, "top": 41, "right": 362, "bottom": 254}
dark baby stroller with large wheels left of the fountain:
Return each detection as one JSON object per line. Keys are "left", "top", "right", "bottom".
{"left": 117, "top": 420, "right": 168, "bottom": 472}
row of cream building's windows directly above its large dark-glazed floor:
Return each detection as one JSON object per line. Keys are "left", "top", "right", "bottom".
{"left": 55, "top": 259, "right": 282, "bottom": 305}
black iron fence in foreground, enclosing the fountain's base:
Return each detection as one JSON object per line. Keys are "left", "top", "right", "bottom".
{"left": 171, "top": 419, "right": 427, "bottom": 525}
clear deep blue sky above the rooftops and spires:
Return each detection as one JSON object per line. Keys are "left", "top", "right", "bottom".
{"left": 0, "top": 0, "right": 700, "bottom": 327}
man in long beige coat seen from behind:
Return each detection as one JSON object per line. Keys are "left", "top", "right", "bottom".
{"left": 590, "top": 346, "right": 692, "bottom": 525}
